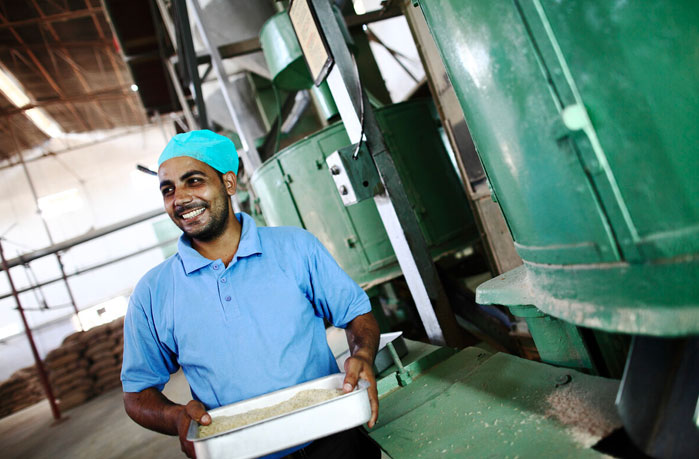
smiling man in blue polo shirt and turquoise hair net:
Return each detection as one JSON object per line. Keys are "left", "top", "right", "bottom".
{"left": 121, "top": 130, "right": 380, "bottom": 458}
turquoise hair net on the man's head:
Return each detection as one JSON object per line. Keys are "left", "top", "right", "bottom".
{"left": 158, "top": 129, "right": 238, "bottom": 174}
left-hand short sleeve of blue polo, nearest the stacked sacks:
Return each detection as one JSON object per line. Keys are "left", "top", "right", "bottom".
{"left": 121, "top": 287, "right": 179, "bottom": 392}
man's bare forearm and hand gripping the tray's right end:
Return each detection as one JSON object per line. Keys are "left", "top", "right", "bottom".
{"left": 343, "top": 312, "right": 379, "bottom": 428}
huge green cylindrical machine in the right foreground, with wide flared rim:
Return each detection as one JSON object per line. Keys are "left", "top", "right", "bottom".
{"left": 413, "top": 0, "right": 699, "bottom": 457}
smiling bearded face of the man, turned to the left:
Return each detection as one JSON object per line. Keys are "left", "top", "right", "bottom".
{"left": 158, "top": 156, "right": 235, "bottom": 242}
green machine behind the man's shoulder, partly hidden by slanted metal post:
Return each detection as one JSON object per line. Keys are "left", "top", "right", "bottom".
{"left": 251, "top": 12, "right": 478, "bottom": 287}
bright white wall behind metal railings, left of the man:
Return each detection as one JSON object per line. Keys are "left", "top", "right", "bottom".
{"left": 0, "top": 127, "right": 180, "bottom": 380}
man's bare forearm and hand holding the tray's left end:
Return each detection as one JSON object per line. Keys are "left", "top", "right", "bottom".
{"left": 124, "top": 387, "right": 211, "bottom": 457}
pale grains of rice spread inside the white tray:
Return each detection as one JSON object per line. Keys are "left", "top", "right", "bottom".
{"left": 199, "top": 389, "right": 342, "bottom": 438}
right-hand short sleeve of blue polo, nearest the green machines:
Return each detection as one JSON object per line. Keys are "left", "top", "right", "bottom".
{"left": 308, "top": 235, "right": 371, "bottom": 328}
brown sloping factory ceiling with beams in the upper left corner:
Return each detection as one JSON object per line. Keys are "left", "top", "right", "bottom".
{"left": 0, "top": 0, "right": 152, "bottom": 164}
